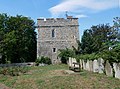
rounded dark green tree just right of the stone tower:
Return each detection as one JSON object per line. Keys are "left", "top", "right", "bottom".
{"left": 81, "top": 24, "right": 116, "bottom": 54}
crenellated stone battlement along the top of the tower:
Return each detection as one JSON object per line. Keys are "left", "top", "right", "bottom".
{"left": 37, "top": 16, "right": 79, "bottom": 27}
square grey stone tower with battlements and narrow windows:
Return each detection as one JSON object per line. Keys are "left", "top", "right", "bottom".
{"left": 37, "top": 16, "right": 79, "bottom": 64}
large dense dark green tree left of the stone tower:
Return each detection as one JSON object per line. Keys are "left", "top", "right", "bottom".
{"left": 0, "top": 14, "right": 36, "bottom": 62}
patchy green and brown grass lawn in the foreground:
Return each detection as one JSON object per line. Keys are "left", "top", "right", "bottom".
{"left": 0, "top": 65, "right": 120, "bottom": 89}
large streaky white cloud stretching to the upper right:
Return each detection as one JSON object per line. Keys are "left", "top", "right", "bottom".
{"left": 49, "top": 0, "right": 119, "bottom": 17}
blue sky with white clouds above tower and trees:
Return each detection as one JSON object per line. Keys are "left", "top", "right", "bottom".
{"left": 0, "top": 0, "right": 120, "bottom": 37}
